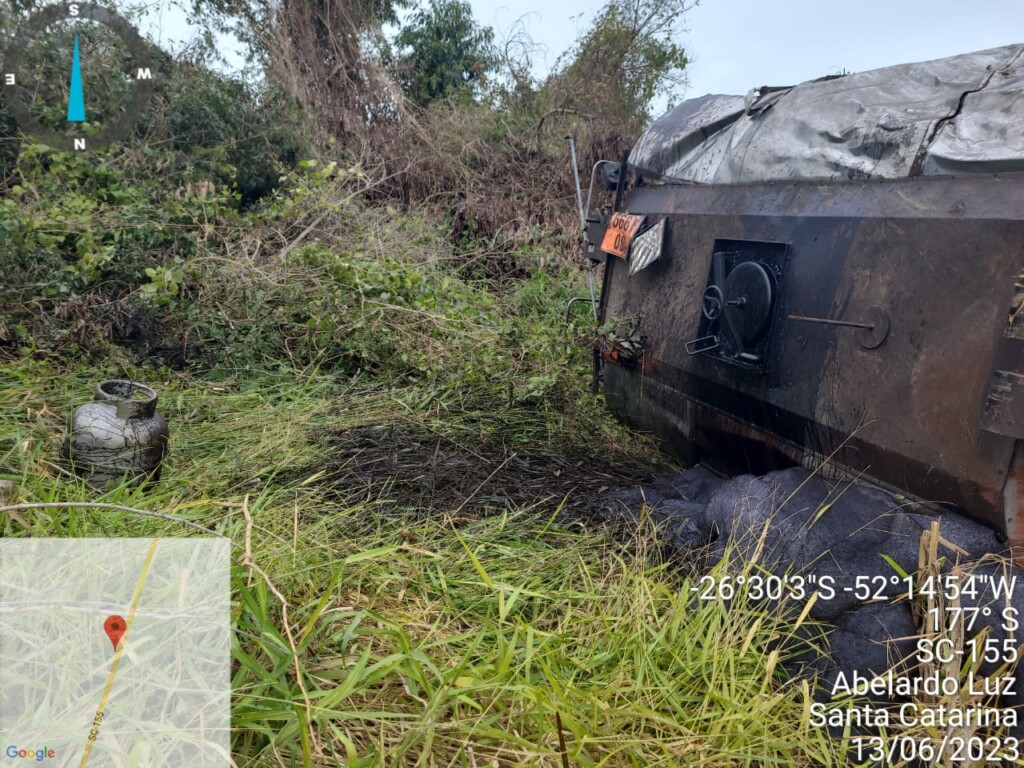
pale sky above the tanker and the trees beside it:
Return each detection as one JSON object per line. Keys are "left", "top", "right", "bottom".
{"left": 471, "top": 0, "right": 1024, "bottom": 102}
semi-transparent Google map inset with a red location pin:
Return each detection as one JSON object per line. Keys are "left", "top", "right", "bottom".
{"left": 0, "top": 539, "right": 231, "bottom": 768}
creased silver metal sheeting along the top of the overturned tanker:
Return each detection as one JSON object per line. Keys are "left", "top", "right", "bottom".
{"left": 630, "top": 45, "right": 1024, "bottom": 183}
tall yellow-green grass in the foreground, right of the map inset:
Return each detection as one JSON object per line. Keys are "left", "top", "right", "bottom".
{"left": 234, "top": 514, "right": 831, "bottom": 766}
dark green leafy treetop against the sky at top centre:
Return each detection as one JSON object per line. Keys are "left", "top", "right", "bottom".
{"left": 393, "top": 0, "right": 497, "bottom": 105}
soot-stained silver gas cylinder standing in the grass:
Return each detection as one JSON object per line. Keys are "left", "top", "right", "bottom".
{"left": 62, "top": 379, "right": 169, "bottom": 485}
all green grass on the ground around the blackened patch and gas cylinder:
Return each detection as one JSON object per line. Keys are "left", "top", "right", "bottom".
{"left": 0, "top": 361, "right": 834, "bottom": 767}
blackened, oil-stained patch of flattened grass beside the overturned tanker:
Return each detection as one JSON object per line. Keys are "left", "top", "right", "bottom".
{"left": 317, "top": 426, "right": 666, "bottom": 519}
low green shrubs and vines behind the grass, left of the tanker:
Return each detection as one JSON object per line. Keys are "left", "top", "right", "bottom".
{"left": 0, "top": 145, "right": 588, "bottom": 408}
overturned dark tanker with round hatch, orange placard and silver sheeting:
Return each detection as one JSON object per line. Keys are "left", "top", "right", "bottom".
{"left": 586, "top": 45, "right": 1024, "bottom": 562}
